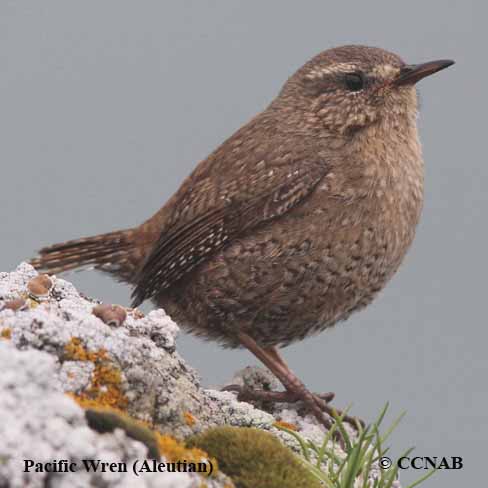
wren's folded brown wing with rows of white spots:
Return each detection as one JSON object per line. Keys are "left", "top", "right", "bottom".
{"left": 132, "top": 143, "right": 327, "bottom": 306}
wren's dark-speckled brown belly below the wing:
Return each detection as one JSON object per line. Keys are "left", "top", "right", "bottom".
{"left": 158, "top": 196, "right": 413, "bottom": 347}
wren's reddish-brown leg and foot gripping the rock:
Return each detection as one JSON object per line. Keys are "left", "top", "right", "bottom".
{"left": 228, "top": 332, "right": 358, "bottom": 429}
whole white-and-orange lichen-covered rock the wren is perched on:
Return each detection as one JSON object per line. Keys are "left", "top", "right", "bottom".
{"left": 0, "top": 263, "right": 396, "bottom": 488}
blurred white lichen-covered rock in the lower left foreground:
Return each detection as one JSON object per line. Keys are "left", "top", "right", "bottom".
{"left": 0, "top": 340, "right": 229, "bottom": 488}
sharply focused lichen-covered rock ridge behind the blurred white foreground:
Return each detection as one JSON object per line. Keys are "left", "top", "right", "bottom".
{"left": 0, "top": 264, "right": 274, "bottom": 438}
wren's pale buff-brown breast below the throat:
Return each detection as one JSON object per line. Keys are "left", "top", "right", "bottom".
{"left": 309, "top": 120, "right": 424, "bottom": 281}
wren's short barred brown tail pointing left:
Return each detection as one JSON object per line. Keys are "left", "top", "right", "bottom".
{"left": 30, "top": 229, "right": 137, "bottom": 281}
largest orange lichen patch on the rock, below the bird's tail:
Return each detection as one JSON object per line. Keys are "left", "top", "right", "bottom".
{"left": 64, "top": 337, "right": 129, "bottom": 411}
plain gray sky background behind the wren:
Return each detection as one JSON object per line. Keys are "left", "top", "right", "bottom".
{"left": 0, "top": 0, "right": 482, "bottom": 488}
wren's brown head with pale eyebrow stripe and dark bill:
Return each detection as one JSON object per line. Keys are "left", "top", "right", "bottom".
{"left": 276, "top": 46, "right": 454, "bottom": 136}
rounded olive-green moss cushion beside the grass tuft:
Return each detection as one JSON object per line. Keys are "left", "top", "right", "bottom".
{"left": 187, "top": 427, "right": 322, "bottom": 488}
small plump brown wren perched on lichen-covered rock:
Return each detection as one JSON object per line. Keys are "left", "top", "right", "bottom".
{"left": 31, "top": 45, "right": 454, "bottom": 429}
